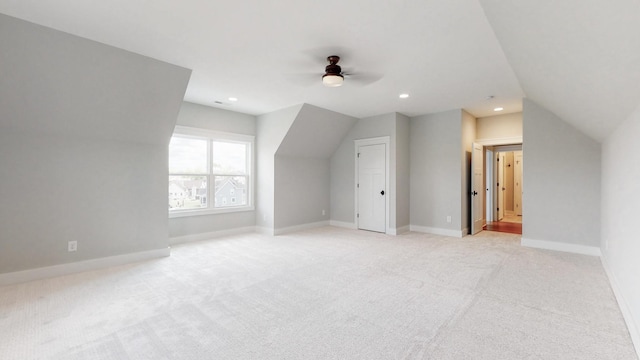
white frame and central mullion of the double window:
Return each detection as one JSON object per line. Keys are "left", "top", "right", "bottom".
{"left": 167, "top": 125, "right": 255, "bottom": 218}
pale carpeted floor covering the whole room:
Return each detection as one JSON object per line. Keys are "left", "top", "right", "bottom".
{"left": 0, "top": 227, "right": 636, "bottom": 360}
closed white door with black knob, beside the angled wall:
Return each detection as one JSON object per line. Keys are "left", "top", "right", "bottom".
{"left": 357, "top": 144, "right": 387, "bottom": 233}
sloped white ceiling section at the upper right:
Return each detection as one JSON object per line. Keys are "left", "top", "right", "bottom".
{"left": 480, "top": 0, "right": 640, "bottom": 140}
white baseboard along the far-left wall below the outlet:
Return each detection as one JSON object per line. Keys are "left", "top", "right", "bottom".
{"left": 0, "top": 247, "right": 171, "bottom": 286}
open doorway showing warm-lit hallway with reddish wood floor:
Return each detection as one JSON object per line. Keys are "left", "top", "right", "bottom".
{"left": 484, "top": 144, "right": 524, "bottom": 234}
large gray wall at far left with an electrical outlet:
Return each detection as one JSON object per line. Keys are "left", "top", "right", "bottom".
{"left": 0, "top": 15, "right": 190, "bottom": 273}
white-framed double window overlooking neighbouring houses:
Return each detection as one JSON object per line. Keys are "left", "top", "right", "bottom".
{"left": 169, "top": 126, "right": 253, "bottom": 217}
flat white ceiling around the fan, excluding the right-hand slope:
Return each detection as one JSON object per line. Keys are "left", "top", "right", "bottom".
{"left": 0, "top": 0, "right": 523, "bottom": 118}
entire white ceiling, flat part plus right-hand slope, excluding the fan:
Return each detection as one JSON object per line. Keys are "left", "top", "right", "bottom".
{"left": 0, "top": 0, "right": 640, "bottom": 139}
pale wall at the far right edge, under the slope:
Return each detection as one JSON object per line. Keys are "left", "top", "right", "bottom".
{"left": 601, "top": 102, "right": 640, "bottom": 348}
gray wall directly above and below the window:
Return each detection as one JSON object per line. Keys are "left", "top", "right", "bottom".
{"left": 169, "top": 102, "right": 256, "bottom": 238}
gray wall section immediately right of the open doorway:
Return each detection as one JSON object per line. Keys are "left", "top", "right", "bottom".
{"left": 522, "top": 99, "right": 600, "bottom": 247}
